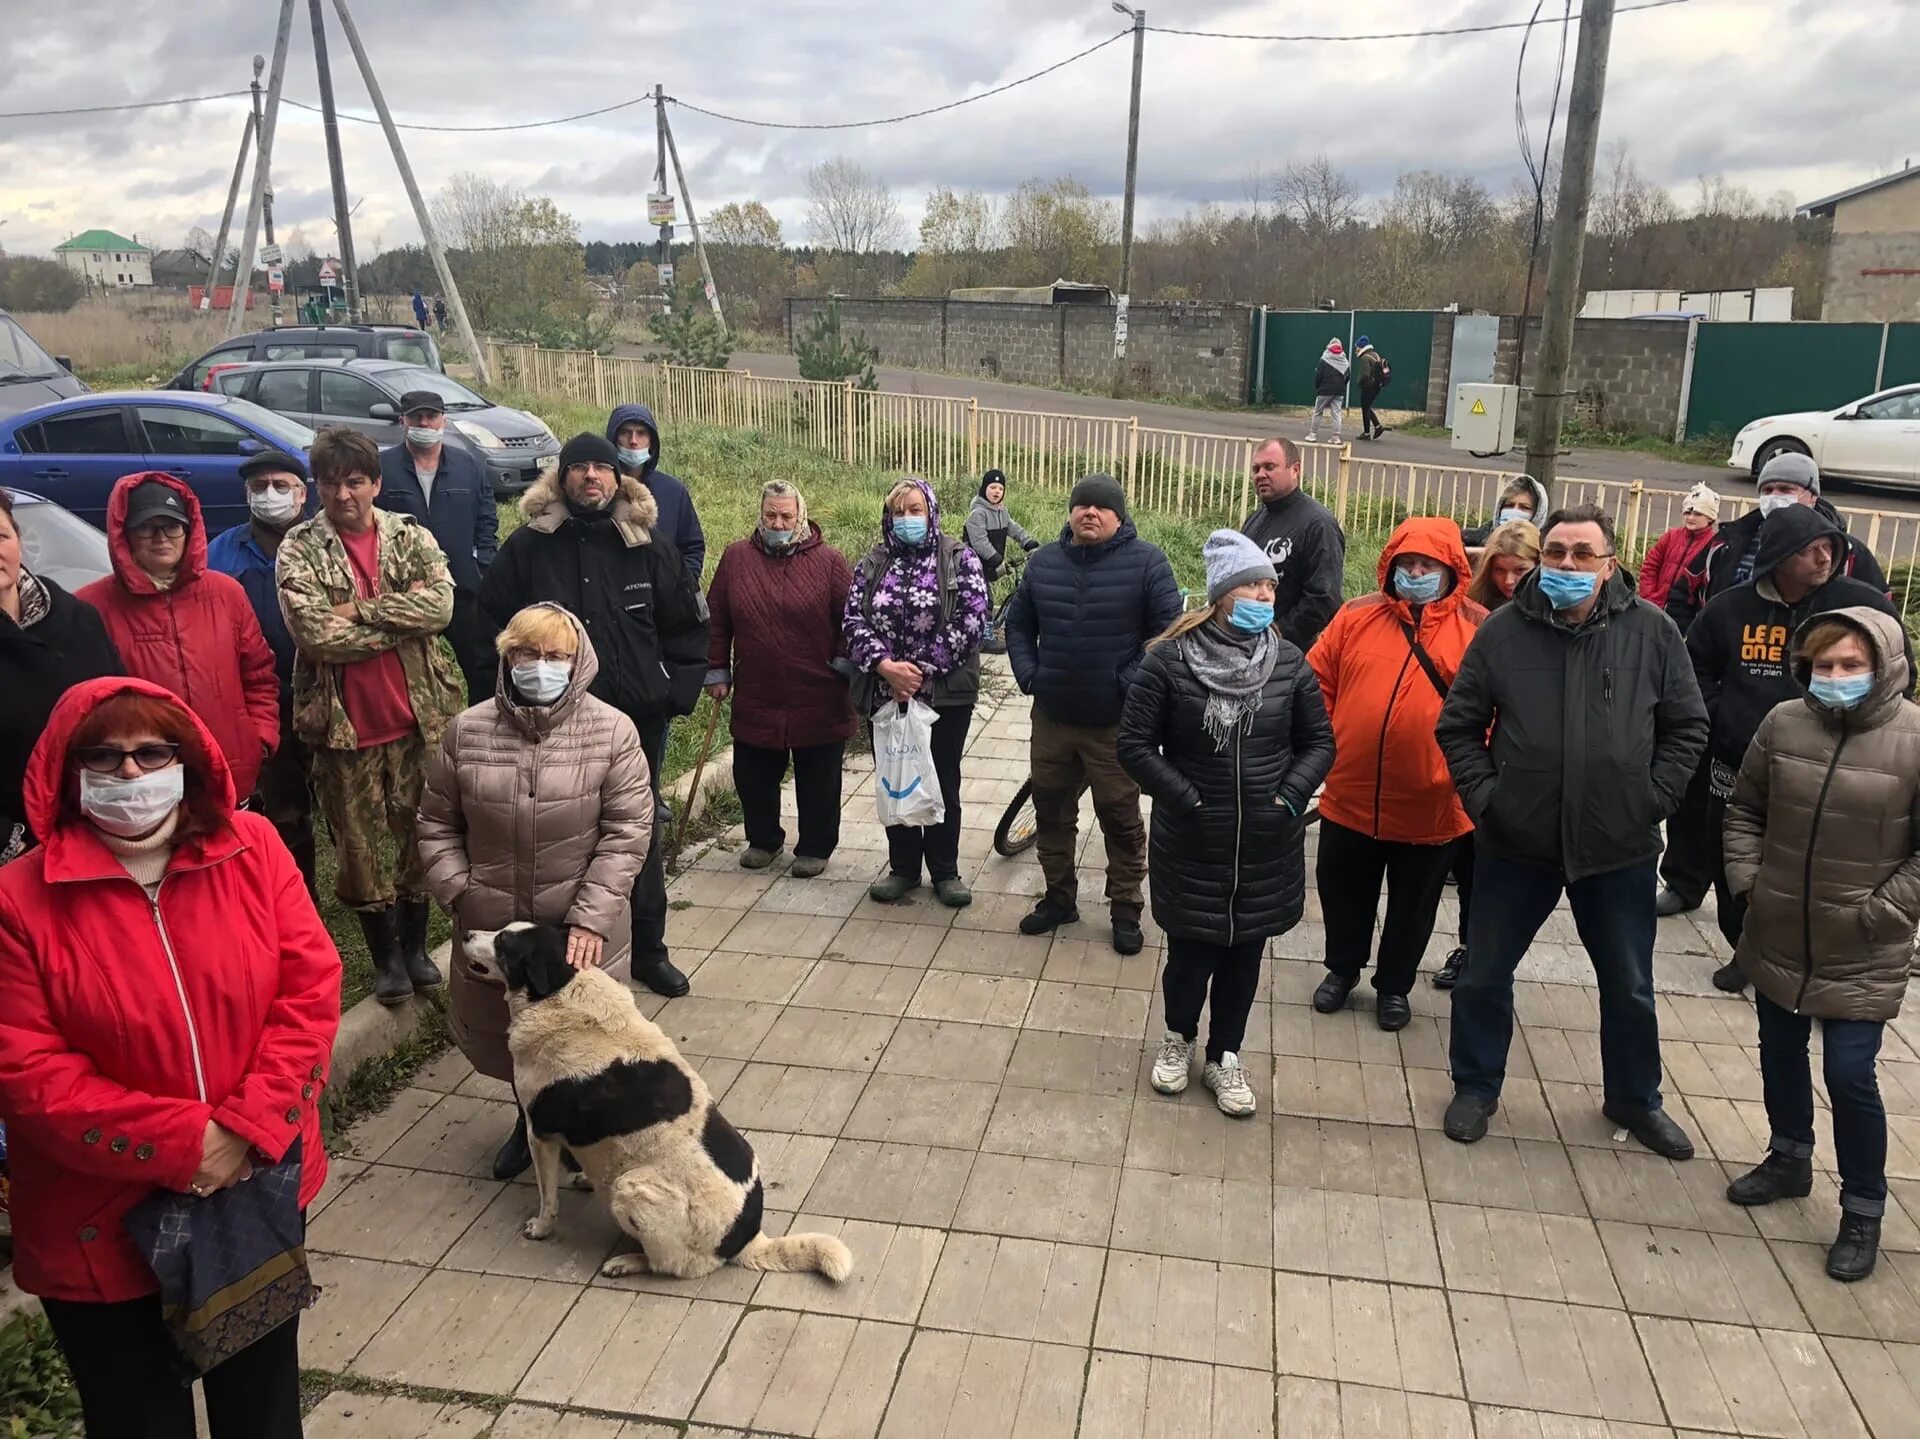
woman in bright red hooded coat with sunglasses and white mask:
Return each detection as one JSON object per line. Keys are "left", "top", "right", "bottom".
{"left": 0, "top": 678, "right": 340, "bottom": 1439}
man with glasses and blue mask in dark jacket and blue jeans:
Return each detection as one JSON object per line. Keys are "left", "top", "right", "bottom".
{"left": 1434, "top": 505, "right": 1707, "bottom": 1159}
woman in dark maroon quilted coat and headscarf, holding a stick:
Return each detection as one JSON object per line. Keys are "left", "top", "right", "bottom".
{"left": 707, "top": 480, "right": 854, "bottom": 880}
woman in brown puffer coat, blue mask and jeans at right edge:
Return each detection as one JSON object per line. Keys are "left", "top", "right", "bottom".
{"left": 1726, "top": 607, "right": 1920, "bottom": 1280}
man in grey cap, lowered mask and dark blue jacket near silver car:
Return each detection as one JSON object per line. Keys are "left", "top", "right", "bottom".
{"left": 376, "top": 390, "right": 499, "bottom": 705}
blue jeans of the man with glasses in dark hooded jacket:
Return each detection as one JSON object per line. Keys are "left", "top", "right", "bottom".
{"left": 1452, "top": 845, "right": 1661, "bottom": 1109}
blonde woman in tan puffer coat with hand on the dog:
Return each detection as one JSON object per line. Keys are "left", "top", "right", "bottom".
{"left": 417, "top": 603, "right": 653, "bottom": 1180}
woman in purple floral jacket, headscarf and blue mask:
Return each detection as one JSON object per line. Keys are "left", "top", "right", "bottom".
{"left": 843, "top": 480, "right": 987, "bottom": 909}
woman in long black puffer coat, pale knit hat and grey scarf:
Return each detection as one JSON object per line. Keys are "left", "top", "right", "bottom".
{"left": 1117, "top": 530, "right": 1334, "bottom": 1118}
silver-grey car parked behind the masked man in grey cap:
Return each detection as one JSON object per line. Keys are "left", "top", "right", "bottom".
{"left": 213, "top": 359, "right": 561, "bottom": 498}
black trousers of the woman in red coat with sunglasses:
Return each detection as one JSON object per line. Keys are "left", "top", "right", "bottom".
{"left": 40, "top": 1295, "right": 300, "bottom": 1439}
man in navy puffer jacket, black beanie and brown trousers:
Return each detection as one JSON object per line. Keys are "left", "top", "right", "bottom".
{"left": 1006, "top": 475, "right": 1181, "bottom": 955}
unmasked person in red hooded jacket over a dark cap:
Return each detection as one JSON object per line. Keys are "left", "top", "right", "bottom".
{"left": 79, "top": 471, "right": 280, "bottom": 801}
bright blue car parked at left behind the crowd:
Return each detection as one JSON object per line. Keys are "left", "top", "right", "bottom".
{"left": 0, "top": 390, "right": 313, "bottom": 534}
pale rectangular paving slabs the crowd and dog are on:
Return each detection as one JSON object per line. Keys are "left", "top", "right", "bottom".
{"left": 301, "top": 672, "right": 1920, "bottom": 1439}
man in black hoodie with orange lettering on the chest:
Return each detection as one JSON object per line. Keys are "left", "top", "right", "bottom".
{"left": 1686, "top": 505, "right": 1912, "bottom": 993}
